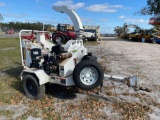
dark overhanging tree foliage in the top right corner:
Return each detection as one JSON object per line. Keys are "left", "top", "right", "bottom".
{"left": 137, "top": 0, "right": 160, "bottom": 15}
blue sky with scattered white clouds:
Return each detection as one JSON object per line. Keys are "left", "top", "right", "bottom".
{"left": 0, "top": 0, "right": 152, "bottom": 33}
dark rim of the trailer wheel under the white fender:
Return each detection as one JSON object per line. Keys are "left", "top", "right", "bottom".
{"left": 26, "top": 79, "right": 38, "bottom": 96}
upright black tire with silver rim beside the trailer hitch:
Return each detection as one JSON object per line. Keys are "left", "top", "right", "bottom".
{"left": 73, "top": 60, "right": 104, "bottom": 90}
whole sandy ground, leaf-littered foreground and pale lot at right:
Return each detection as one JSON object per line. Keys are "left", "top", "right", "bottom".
{"left": 0, "top": 38, "right": 160, "bottom": 120}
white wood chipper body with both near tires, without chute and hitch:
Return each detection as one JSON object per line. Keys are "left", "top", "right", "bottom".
{"left": 19, "top": 30, "right": 104, "bottom": 99}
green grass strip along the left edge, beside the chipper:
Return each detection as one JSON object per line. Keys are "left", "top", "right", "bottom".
{"left": 0, "top": 38, "right": 22, "bottom": 104}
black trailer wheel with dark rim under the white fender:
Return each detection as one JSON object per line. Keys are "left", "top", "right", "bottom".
{"left": 23, "top": 75, "right": 45, "bottom": 100}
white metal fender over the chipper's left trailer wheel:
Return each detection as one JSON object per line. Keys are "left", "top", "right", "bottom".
{"left": 20, "top": 69, "right": 50, "bottom": 85}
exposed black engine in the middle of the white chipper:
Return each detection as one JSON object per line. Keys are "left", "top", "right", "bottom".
{"left": 30, "top": 44, "right": 72, "bottom": 75}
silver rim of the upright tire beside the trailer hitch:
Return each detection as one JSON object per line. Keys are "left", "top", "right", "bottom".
{"left": 80, "top": 67, "right": 98, "bottom": 85}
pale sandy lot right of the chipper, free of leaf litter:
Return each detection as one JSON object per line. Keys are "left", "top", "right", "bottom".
{"left": 88, "top": 38, "right": 160, "bottom": 120}
